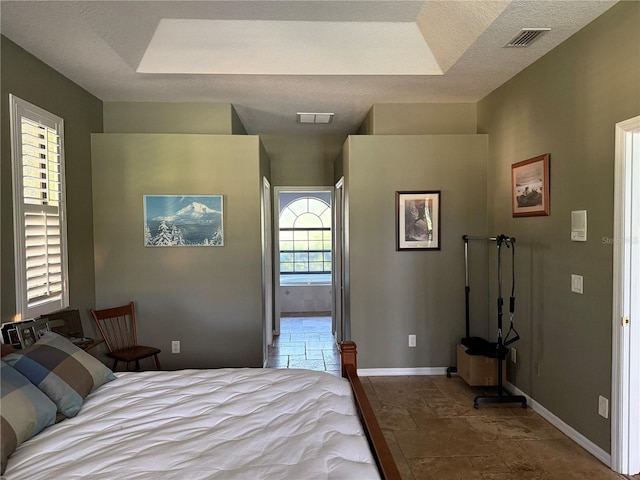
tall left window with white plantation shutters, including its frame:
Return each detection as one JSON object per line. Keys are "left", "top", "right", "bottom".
{"left": 9, "top": 95, "right": 69, "bottom": 319}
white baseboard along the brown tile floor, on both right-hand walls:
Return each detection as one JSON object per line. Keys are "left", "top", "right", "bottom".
{"left": 358, "top": 367, "right": 611, "bottom": 468}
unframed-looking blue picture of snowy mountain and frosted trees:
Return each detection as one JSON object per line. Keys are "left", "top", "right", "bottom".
{"left": 144, "top": 195, "right": 224, "bottom": 247}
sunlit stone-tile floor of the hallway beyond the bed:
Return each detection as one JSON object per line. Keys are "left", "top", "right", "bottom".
{"left": 267, "top": 317, "right": 340, "bottom": 376}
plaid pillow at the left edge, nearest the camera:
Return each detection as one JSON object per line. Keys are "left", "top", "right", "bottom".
{"left": 0, "top": 362, "right": 56, "bottom": 473}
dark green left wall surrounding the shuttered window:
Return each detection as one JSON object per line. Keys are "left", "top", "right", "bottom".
{"left": 0, "top": 36, "right": 102, "bottom": 334}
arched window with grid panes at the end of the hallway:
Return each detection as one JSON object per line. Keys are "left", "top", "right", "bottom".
{"left": 279, "top": 197, "right": 331, "bottom": 285}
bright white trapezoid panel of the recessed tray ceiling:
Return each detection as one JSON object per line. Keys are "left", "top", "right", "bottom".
{"left": 137, "top": 19, "right": 442, "bottom": 75}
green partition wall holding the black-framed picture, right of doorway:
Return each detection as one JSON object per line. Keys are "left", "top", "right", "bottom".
{"left": 342, "top": 135, "right": 487, "bottom": 368}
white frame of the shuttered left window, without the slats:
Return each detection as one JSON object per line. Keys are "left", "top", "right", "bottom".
{"left": 9, "top": 94, "right": 69, "bottom": 319}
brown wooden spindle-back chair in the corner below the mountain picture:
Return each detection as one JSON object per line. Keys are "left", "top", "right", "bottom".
{"left": 91, "top": 302, "right": 161, "bottom": 371}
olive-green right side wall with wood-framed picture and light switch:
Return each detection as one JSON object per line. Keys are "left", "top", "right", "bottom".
{"left": 478, "top": 2, "right": 640, "bottom": 451}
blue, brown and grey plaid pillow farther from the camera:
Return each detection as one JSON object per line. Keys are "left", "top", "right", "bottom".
{"left": 3, "top": 332, "right": 116, "bottom": 417}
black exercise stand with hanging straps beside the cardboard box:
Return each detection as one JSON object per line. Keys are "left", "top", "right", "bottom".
{"left": 447, "top": 234, "right": 527, "bottom": 409}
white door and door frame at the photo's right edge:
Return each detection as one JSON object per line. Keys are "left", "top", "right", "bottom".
{"left": 611, "top": 116, "right": 640, "bottom": 475}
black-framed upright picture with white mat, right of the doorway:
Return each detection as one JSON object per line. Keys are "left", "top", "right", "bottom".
{"left": 396, "top": 190, "right": 440, "bottom": 251}
